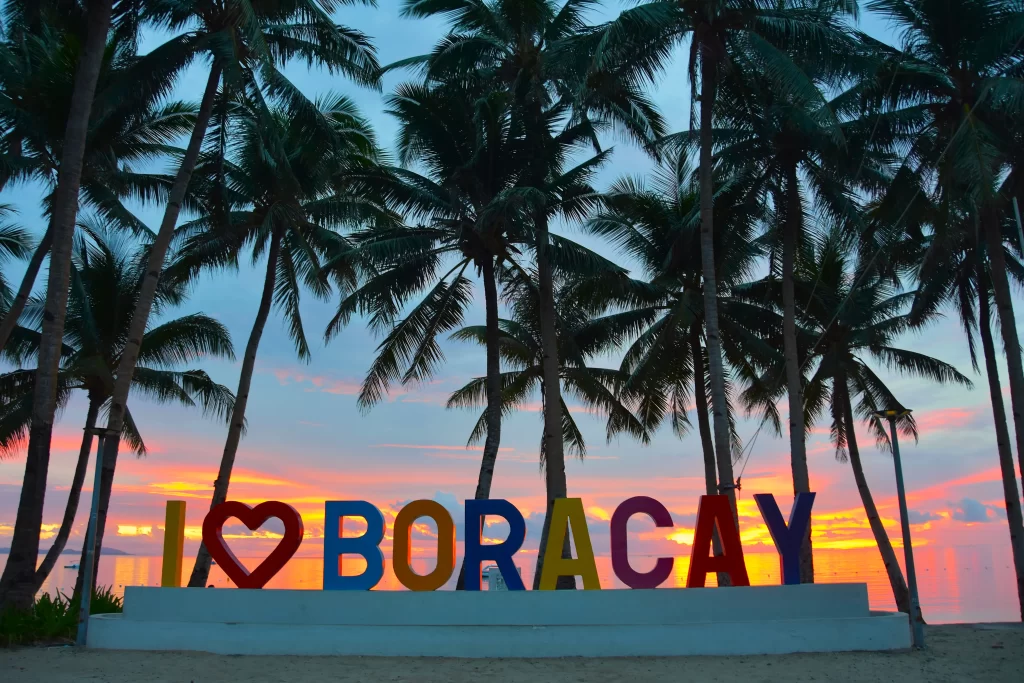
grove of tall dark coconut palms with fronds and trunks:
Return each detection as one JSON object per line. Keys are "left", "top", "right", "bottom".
{"left": 0, "top": 0, "right": 1024, "bottom": 633}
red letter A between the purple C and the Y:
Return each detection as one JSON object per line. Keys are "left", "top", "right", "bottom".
{"left": 686, "top": 496, "right": 751, "bottom": 588}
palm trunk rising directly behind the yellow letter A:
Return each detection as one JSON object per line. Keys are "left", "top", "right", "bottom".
{"left": 534, "top": 210, "right": 575, "bottom": 591}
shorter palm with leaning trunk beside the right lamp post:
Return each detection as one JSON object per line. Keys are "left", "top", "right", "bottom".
{"left": 744, "top": 233, "right": 972, "bottom": 620}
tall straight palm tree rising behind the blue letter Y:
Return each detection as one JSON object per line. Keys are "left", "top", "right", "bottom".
{"left": 696, "top": 66, "right": 890, "bottom": 582}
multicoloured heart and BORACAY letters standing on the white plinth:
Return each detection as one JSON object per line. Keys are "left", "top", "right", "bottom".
{"left": 192, "top": 494, "right": 814, "bottom": 591}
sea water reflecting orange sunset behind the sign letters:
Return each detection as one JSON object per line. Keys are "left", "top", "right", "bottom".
{"left": 8, "top": 546, "right": 1020, "bottom": 624}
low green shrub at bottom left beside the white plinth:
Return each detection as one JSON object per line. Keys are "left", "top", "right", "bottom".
{"left": 0, "top": 587, "right": 123, "bottom": 647}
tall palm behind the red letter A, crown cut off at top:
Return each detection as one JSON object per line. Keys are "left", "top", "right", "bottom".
{"left": 592, "top": 0, "right": 856, "bottom": 582}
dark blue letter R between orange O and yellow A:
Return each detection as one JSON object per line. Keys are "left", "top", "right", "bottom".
{"left": 463, "top": 499, "right": 526, "bottom": 591}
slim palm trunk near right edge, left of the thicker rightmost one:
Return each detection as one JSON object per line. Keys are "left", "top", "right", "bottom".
{"left": 978, "top": 267, "right": 1024, "bottom": 621}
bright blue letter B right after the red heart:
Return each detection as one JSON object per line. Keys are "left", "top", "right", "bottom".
{"left": 324, "top": 501, "right": 384, "bottom": 591}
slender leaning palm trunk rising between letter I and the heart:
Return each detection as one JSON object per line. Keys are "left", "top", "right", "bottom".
{"left": 188, "top": 228, "right": 283, "bottom": 588}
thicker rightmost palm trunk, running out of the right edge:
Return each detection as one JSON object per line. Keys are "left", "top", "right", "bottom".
{"left": 984, "top": 211, "right": 1024, "bottom": 493}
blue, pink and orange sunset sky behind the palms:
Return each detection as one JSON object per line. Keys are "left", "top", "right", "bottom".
{"left": 0, "top": 0, "right": 1024, "bottom": 569}
